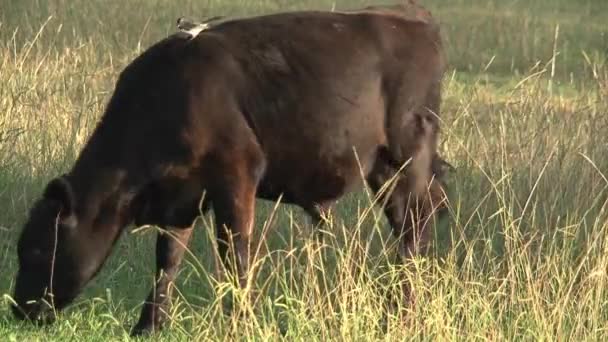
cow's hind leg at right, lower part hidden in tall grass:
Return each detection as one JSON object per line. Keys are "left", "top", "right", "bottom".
{"left": 382, "top": 77, "right": 449, "bottom": 264}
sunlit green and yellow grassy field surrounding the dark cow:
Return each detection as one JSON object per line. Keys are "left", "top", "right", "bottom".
{"left": 0, "top": 0, "right": 608, "bottom": 341}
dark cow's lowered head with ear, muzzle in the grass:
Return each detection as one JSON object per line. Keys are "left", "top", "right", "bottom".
{"left": 12, "top": 177, "right": 116, "bottom": 322}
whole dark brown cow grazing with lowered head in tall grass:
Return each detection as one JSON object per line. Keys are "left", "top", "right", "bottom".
{"left": 12, "top": 3, "right": 446, "bottom": 334}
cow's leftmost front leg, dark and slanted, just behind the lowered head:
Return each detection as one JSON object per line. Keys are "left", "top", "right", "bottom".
{"left": 131, "top": 227, "right": 193, "bottom": 335}
